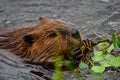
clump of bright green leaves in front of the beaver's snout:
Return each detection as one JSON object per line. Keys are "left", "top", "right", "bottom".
{"left": 91, "top": 34, "right": 120, "bottom": 73}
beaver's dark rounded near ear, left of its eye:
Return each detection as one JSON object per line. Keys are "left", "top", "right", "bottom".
{"left": 23, "top": 34, "right": 34, "bottom": 46}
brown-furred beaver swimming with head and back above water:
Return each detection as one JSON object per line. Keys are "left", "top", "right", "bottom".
{"left": 0, "top": 18, "right": 81, "bottom": 62}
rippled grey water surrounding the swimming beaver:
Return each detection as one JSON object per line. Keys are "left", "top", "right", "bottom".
{"left": 0, "top": 0, "right": 120, "bottom": 80}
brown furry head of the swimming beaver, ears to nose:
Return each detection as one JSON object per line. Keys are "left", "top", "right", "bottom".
{"left": 20, "top": 18, "right": 81, "bottom": 62}
